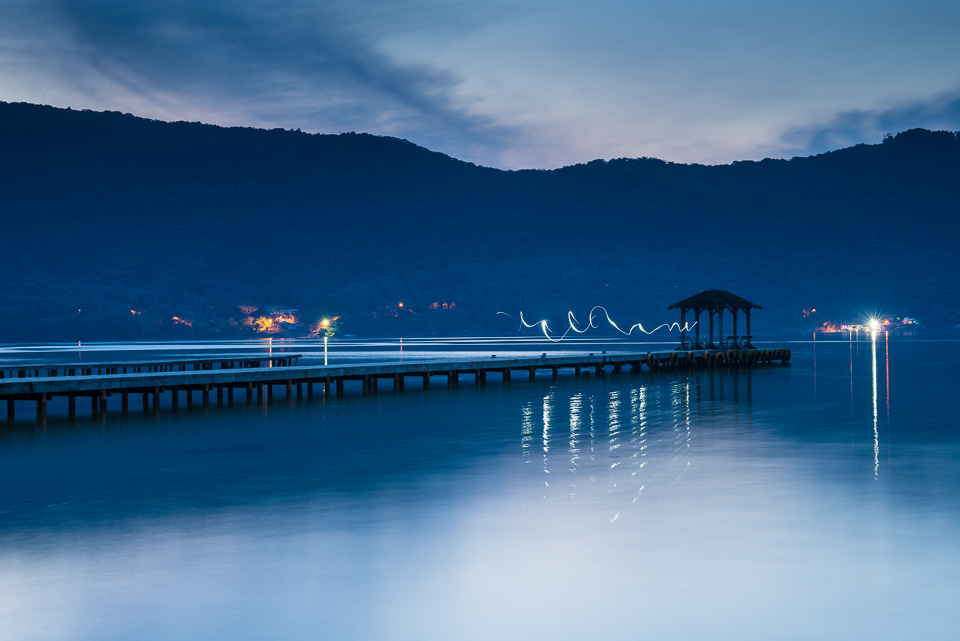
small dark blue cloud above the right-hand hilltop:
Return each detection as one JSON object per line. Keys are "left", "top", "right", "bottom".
{"left": 783, "top": 90, "right": 960, "bottom": 155}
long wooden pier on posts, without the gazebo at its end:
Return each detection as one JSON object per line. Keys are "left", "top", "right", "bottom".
{"left": 0, "top": 346, "right": 790, "bottom": 425}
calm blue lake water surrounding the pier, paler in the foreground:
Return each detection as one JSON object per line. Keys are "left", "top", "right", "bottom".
{"left": 0, "top": 337, "right": 960, "bottom": 641}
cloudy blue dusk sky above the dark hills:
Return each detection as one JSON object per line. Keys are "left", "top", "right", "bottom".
{"left": 0, "top": 0, "right": 960, "bottom": 169}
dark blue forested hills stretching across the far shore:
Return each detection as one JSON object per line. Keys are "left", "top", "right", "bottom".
{"left": 0, "top": 103, "right": 960, "bottom": 342}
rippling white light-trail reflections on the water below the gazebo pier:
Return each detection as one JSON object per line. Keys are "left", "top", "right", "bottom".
{"left": 519, "top": 370, "right": 753, "bottom": 522}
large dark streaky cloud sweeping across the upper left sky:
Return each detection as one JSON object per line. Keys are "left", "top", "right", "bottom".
{"left": 9, "top": 0, "right": 511, "bottom": 165}
